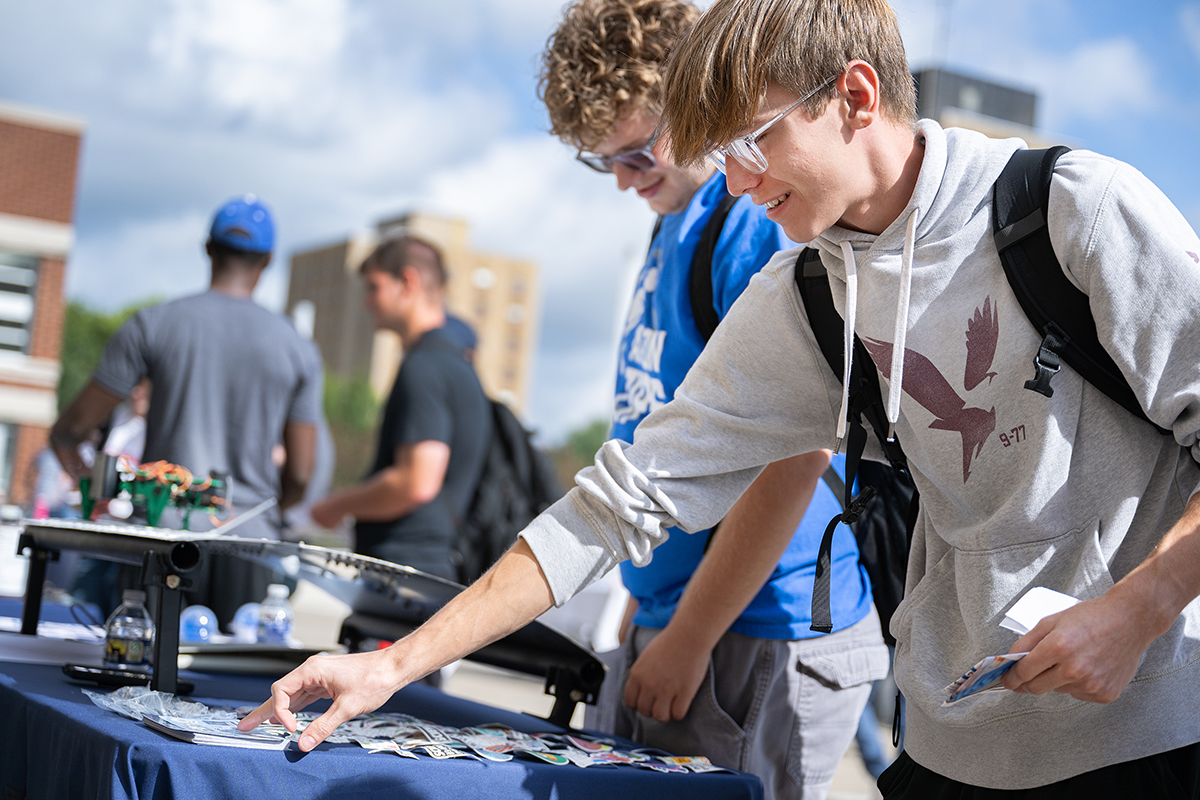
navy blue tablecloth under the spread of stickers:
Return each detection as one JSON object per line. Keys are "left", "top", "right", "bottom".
{"left": 0, "top": 652, "right": 762, "bottom": 800}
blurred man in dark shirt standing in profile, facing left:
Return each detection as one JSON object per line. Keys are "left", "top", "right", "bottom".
{"left": 311, "top": 236, "right": 492, "bottom": 581}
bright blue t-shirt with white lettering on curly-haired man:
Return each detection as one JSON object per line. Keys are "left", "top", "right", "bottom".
{"left": 612, "top": 173, "right": 871, "bottom": 639}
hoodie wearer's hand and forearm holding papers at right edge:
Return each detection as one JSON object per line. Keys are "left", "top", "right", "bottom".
{"left": 1004, "top": 494, "right": 1200, "bottom": 703}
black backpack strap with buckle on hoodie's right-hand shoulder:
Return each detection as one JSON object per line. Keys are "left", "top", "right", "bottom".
{"left": 992, "top": 145, "right": 1169, "bottom": 433}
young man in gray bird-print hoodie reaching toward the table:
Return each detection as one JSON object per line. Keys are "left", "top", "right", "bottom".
{"left": 247, "top": 0, "right": 1200, "bottom": 798}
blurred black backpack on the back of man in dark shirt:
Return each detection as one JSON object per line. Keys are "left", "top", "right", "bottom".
{"left": 454, "top": 399, "right": 563, "bottom": 585}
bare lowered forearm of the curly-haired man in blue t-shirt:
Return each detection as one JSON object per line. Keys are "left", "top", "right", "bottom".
{"left": 625, "top": 450, "right": 830, "bottom": 722}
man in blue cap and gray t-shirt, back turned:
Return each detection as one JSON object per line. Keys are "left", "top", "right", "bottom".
{"left": 50, "top": 194, "right": 324, "bottom": 625}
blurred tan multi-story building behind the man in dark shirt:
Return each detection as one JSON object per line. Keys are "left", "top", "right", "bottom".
{"left": 288, "top": 213, "right": 539, "bottom": 413}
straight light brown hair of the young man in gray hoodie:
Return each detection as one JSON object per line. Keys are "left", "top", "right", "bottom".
{"left": 662, "top": 0, "right": 917, "bottom": 164}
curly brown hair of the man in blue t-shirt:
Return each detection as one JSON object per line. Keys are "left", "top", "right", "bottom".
{"left": 538, "top": 0, "right": 700, "bottom": 150}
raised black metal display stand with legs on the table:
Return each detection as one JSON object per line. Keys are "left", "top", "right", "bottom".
{"left": 20, "top": 517, "right": 605, "bottom": 710}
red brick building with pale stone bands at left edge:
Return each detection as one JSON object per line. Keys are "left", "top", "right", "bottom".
{"left": 0, "top": 101, "right": 84, "bottom": 505}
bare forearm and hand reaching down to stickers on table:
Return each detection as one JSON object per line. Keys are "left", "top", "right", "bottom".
{"left": 238, "top": 540, "right": 552, "bottom": 752}
